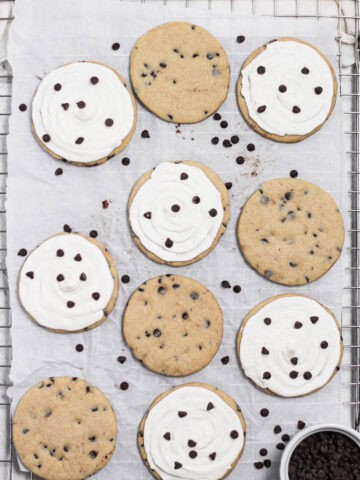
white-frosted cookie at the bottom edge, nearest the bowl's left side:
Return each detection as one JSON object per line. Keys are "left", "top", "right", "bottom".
{"left": 138, "top": 383, "right": 246, "bottom": 480}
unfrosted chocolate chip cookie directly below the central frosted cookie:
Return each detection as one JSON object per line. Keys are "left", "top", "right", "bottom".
{"left": 123, "top": 275, "right": 223, "bottom": 376}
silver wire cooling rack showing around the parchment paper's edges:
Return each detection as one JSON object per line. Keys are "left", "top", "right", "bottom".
{"left": 0, "top": 0, "right": 360, "bottom": 480}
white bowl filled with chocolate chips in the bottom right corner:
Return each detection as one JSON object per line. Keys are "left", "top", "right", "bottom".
{"left": 280, "top": 424, "right": 360, "bottom": 480}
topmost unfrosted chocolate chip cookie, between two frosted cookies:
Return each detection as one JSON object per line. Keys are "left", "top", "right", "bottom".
{"left": 130, "top": 22, "right": 230, "bottom": 123}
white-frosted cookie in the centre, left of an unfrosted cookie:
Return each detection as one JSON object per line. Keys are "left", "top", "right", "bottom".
{"left": 128, "top": 162, "right": 230, "bottom": 266}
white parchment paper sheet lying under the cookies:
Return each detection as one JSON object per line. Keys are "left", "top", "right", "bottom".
{"left": 7, "top": 0, "right": 347, "bottom": 480}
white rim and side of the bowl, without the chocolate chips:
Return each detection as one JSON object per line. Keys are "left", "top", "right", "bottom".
{"left": 280, "top": 423, "right": 360, "bottom": 480}
